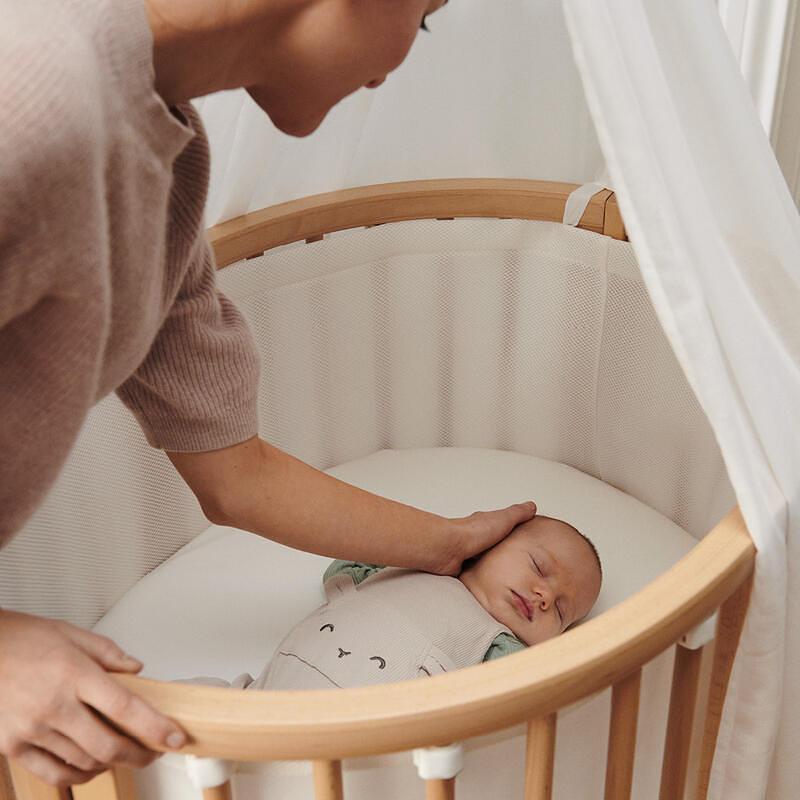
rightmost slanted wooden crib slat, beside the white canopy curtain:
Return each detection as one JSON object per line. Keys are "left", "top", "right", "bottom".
{"left": 697, "top": 575, "right": 753, "bottom": 800}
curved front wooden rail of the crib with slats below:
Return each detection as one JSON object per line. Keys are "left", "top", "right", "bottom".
{"left": 12, "top": 508, "right": 755, "bottom": 800}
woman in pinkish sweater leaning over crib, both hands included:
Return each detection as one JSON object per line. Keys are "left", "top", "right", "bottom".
{"left": 0, "top": 0, "right": 535, "bottom": 785}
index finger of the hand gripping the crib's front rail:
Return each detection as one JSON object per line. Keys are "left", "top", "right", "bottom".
{"left": 77, "top": 670, "right": 186, "bottom": 755}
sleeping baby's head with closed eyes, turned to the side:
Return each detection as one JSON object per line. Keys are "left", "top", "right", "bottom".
{"left": 459, "top": 517, "right": 601, "bottom": 645}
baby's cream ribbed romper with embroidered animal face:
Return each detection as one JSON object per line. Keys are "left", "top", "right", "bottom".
{"left": 250, "top": 568, "right": 523, "bottom": 689}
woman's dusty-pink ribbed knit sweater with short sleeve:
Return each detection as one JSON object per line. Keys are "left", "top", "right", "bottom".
{"left": 0, "top": 0, "right": 258, "bottom": 543}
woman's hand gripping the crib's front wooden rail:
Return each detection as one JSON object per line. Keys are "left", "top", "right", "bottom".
{"left": 0, "top": 611, "right": 185, "bottom": 786}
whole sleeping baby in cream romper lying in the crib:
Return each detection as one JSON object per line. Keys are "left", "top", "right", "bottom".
{"left": 199, "top": 516, "right": 602, "bottom": 689}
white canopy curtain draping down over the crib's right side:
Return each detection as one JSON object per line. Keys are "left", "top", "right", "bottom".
{"left": 564, "top": 0, "right": 800, "bottom": 800}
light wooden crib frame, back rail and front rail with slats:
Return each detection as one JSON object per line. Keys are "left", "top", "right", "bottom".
{"left": 0, "top": 180, "right": 755, "bottom": 800}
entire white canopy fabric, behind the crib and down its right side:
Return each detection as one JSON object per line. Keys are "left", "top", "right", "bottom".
{"left": 195, "top": 0, "right": 800, "bottom": 800}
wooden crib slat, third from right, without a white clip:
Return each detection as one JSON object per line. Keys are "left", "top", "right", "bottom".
{"left": 605, "top": 668, "right": 642, "bottom": 800}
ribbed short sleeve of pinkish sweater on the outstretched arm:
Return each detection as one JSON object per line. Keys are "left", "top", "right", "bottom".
{"left": 117, "top": 105, "right": 259, "bottom": 452}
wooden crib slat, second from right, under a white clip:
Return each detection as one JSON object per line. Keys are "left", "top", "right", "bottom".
{"left": 659, "top": 645, "right": 704, "bottom": 800}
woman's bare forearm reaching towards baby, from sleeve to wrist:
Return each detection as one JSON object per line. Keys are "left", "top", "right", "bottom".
{"left": 170, "top": 438, "right": 462, "bottom": 573}
